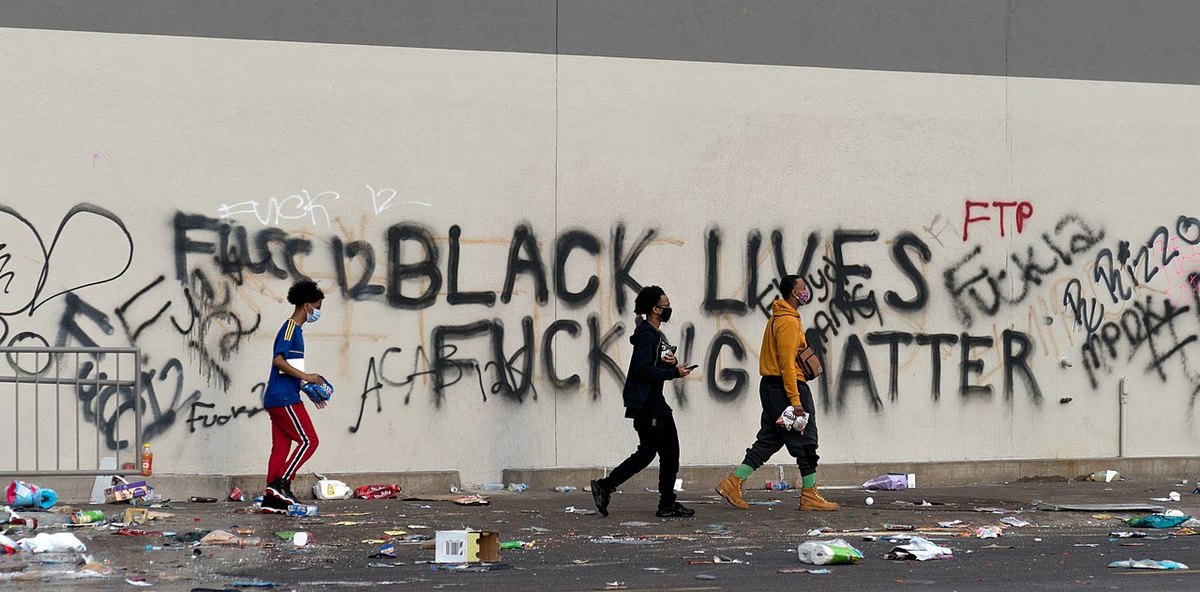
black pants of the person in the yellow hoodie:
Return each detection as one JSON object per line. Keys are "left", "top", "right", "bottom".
{"left": 742, "top": 376, "right": 820, "bottom": 477}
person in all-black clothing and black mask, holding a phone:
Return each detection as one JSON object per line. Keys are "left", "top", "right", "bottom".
{"left": 592, "top": 286, "right": 696, "bottom": 518}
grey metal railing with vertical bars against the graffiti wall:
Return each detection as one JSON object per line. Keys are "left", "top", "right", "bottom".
{"left": 0, "top": 347, "right": 144, "bottom": 477}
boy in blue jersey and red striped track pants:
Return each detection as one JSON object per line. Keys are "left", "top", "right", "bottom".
{"left": 263, "top": 280, "right": 325, "bottom": 512}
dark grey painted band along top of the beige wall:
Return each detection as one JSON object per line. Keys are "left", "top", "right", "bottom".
{"left": 0, "top": 0, "right": 1200, "bottom": 84}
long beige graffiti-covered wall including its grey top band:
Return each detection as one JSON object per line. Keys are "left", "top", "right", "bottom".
{"left": 0, "top": 1, "right": 1200, "bottom": 484}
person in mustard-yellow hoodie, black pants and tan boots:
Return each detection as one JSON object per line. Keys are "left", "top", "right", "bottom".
{"left": 716, "top": 275, "right": 838, "bottom": 510}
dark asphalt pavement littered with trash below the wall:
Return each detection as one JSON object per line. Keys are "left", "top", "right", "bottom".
{"left": 0, "top": 480, "right": 1200, "bottom": 592}
